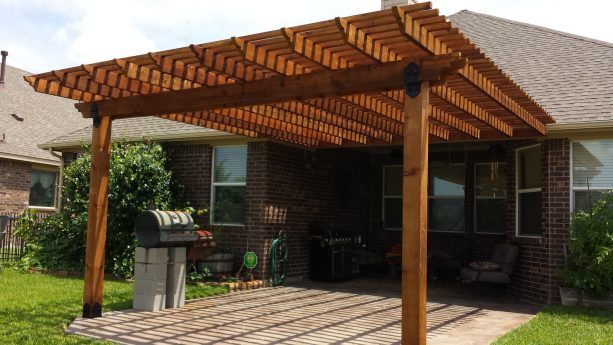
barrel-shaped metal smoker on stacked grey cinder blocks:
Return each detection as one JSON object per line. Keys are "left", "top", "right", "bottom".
{"left": 134, "top": 210, "right": 200, "bottom": 311}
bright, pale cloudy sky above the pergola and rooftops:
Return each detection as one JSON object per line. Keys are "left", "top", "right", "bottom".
{"left": 0, "top": 0, "right": 613, "bottom": 73}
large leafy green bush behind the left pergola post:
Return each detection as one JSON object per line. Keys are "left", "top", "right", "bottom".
{"left": 18, "top": 143, "right": 176, "bottom": 277}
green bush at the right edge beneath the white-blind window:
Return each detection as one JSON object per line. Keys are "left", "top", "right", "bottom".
{"left": 561, "top": 192, "right": 613, "bottom": 297}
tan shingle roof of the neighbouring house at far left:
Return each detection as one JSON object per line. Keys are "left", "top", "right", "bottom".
{"left": 0, "top": 65, "right": 90, "bottom": 165}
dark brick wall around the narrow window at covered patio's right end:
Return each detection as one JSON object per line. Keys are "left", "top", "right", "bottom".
{"left": 507, "top": 139, "right": 570, "bottom": 303}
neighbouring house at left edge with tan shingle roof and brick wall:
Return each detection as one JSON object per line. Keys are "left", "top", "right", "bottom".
{"left": 0, "top": 52, "right": 89, "bottom": 214}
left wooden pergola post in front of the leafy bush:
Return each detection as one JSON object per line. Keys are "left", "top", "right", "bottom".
{"left": 83, "top": 116, "right": 112, "bottom": 318}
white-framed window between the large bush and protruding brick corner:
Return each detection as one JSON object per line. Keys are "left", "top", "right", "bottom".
{"left": 211, "top": 146, "right": 247, "bottom": 225}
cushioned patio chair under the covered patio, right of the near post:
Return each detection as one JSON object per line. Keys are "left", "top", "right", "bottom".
{"left": 460, "top": 243, "right": 519, "bottom": 284}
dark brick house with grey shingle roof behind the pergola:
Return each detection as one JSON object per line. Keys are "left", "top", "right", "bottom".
{"left": 40, "top": 11, "right": 613, "bottom": 302}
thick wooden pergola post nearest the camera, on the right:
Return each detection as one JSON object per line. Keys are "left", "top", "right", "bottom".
{"left": 402, "top": 81, "right": 430, "bottom": 345}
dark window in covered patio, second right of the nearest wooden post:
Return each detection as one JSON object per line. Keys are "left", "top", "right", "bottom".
{"left": 475, "top": 163, "right": 507, "bottom": 234}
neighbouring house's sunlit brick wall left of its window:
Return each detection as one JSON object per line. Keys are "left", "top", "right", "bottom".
{"left": 0, "top": 159, "right": 31, "bottom": 213}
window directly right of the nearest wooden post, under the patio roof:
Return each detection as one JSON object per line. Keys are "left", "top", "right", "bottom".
{"left": 428, "top": 164, "right": 465, "bottom": 232}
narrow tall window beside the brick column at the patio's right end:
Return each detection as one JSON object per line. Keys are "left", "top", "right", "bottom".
{"left": 515, "top": 145, "right": 541, "bottom": 236}
